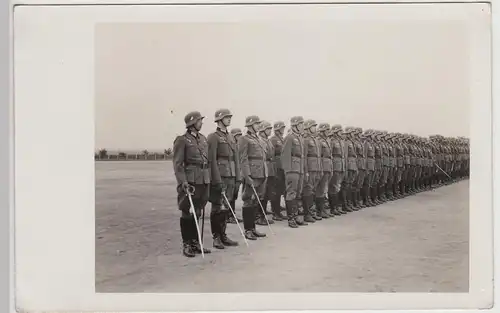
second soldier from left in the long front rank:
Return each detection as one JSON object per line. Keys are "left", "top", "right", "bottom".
{"left": 302, "top": 120, "right": 323, "bottom": 223}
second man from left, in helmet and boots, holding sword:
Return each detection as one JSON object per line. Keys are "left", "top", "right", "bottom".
{"left": 207, "top": 109, "right": 240, "bottom": 249}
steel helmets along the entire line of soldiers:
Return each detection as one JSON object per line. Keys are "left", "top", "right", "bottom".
{"left": 184, "top": 109, "right": 469, "bottom": 146}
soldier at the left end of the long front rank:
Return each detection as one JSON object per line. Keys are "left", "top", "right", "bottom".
{"left": 281, "top": 116, "right": 307, "bottom": 228}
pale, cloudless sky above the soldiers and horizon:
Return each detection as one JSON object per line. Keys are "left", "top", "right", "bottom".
{"left": 95, "top": 21, "right": 470, "bottom": 150}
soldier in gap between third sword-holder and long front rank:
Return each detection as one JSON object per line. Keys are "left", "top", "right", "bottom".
{"left": 271, "top": 121, "right": 285, "bottom": 221}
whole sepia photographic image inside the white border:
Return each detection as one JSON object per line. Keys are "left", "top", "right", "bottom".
{"left": 94, "top": 19, "right": 472, "bottom": 293}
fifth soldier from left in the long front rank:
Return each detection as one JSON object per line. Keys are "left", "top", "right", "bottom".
{"left": 342, "top": 126, "right": 358, "bottom": 212}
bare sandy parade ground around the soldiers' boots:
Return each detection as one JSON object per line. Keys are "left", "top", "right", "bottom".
{"left": 95, "top": 161, "right": 469, "bottom": 292}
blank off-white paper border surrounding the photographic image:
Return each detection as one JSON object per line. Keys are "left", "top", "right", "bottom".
{"left": 9, "top": 0, "right": 499, "bottom": 311}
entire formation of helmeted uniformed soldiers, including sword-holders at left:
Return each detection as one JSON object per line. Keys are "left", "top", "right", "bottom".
{"left": 173, "top": 109, "right": 469, "bottom": 257}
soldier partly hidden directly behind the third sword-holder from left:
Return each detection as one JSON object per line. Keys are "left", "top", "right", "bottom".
{"left": 256, "top": 121, "right": 276, "bottom": 226}
